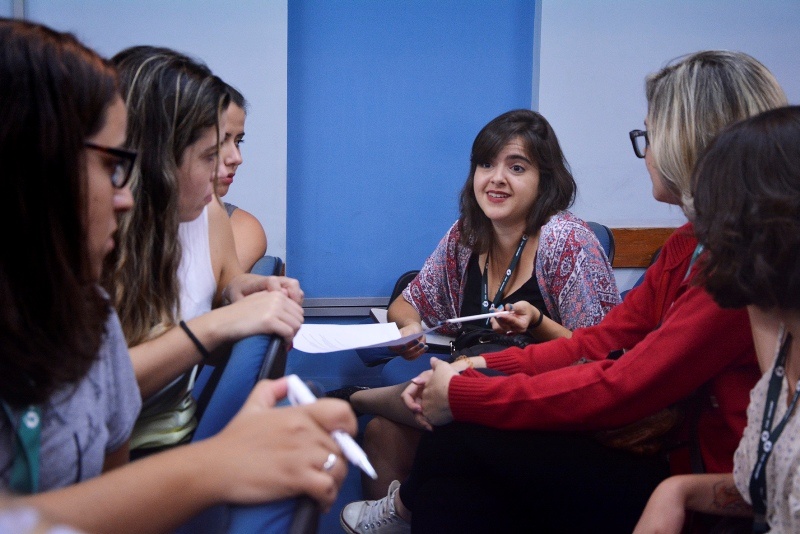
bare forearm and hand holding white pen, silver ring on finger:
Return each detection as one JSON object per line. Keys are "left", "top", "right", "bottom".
{"left": 14, "top": 380, "right": 356, "bottom": 533}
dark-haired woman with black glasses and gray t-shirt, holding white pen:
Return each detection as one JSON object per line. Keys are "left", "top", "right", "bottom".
{"left": 0, "top": 19, "right": 356, "bottom": 533}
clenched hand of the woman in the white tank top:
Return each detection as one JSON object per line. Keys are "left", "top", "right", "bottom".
{"left": 212, "top": 291, "right": 303, "bottom": 346}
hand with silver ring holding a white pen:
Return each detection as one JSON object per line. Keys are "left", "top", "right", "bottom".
{"left": 203, "top": 379, "right": 357, "bottom": 511}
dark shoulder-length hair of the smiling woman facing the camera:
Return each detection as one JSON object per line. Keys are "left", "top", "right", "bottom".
{"left": 459, "top": 109, "right": 577, "bottom": 252}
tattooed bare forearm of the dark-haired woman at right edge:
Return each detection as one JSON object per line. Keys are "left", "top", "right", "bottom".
{"left": 634, "top": 473, "right": 753, "bottom": 534}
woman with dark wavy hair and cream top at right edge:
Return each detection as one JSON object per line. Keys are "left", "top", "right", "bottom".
{"left": 637, "top": 106, "right": 800, "bottom": 533}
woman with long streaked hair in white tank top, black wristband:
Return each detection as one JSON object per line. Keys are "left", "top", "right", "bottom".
{"left": 107, "top": 46, "right": 303, "bottom": 455}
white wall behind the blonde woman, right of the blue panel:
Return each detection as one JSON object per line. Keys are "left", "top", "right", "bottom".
{"left": 538, "top": 0, "right": 800, "bottom": 227}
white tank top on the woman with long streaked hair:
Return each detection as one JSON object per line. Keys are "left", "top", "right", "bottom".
{"left": 178, "top": 206, "right": 217, "bottom": 321}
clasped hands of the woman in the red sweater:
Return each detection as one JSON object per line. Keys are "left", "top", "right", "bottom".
{"left": 402, "top": 358, "right": 458, "bottom": 430}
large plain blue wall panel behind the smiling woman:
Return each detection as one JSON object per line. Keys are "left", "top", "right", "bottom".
{"left": 287, "top": 0, "right": 535, "bottom": 298}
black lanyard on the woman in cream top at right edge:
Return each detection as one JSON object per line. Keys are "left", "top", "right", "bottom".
{"left": 750, "top": 326, "right": 800, "bottom": 533}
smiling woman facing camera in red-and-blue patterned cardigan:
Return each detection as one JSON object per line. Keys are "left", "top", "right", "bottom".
{"left": 338, "top": 109, "right": 620, "bottom": 497}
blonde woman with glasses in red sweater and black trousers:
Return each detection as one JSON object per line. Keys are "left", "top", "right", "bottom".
{"left": 341, "top": 51, "right": 786, "bottom": 532}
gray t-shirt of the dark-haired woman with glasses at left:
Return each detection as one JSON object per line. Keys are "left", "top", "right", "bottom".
{"left": 0, "top": 311, "right": 142, "bottom": 491}
